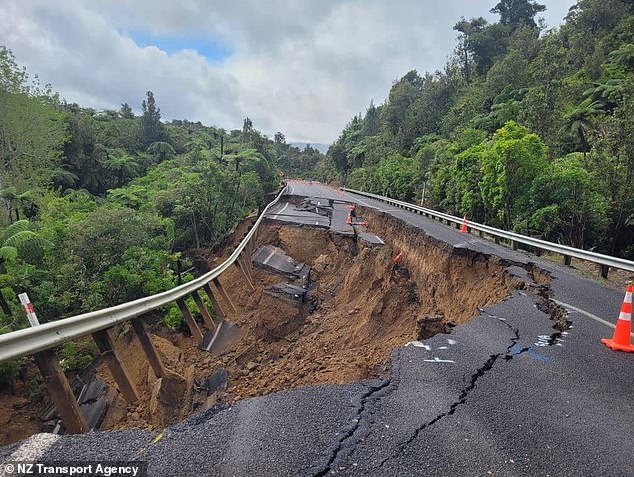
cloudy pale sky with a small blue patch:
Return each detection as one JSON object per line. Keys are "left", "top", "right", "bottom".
{"left": 0, "top": 0, "right": 576, "bottom": 144}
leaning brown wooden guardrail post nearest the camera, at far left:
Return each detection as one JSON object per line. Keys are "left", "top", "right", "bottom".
{"left": 34, "top": 349, "right": 90, "bottom": 434}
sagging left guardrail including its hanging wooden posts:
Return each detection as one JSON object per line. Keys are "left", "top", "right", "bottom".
{"left": 0, "top": 186, "right": 287, "bottom": 434}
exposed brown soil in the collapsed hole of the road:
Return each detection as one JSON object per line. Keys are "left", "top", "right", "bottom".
{"left": 3, "top": 206, "right": 549, "bottom": 443}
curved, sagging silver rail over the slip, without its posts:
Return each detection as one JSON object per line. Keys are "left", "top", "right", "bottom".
{"left": 0, "top": 187, "right": 286, "bottom": 363}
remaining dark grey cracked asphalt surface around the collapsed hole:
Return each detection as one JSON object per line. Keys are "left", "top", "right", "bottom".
{"left": 0, "top": 182, "right": 634, "bottom": 476}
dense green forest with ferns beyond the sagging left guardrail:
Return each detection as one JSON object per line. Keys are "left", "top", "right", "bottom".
{"left": 0, "top": 43, "right": 323, "bottom": 356}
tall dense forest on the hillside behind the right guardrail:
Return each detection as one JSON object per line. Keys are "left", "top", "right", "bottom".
{"left": 315, "top": 0, "right": 634, "bottom": 259}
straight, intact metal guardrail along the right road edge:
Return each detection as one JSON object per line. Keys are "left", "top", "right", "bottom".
{"left": 341, "top": 187, "right": 634, "bottom": 276}
